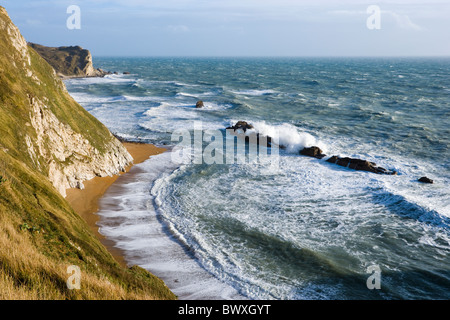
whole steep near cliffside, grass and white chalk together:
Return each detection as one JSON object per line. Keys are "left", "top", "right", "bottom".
{"left": 0, "top": 7, "right": 176, "bottom": 299}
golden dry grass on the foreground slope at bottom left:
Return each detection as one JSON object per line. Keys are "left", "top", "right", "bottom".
{"left": 0, "top": 175, "right": 176, "bottom": 300}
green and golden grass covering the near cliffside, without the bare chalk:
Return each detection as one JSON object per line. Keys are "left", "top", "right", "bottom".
{"left": 0, "top": 8, "right": 176, "bottom": 299}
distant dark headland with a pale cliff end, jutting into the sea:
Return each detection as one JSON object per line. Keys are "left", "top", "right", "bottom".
{"left": 28, "top": 42, "right": 107, "bottom": 77}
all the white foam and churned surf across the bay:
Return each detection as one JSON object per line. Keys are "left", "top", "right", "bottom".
{"left": 69, "top": 58, "right": 450, "bottom": 299}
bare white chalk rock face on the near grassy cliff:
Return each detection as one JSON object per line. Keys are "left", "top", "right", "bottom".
{"left": 25, "top": 97, "right": 133, "bottom": 196}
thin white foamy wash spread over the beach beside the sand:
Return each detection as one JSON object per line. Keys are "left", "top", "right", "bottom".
{"left": 97, "top": 152, "right": 248, "bottom": 300}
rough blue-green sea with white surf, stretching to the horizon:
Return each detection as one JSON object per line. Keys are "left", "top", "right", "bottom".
{"left": 65, "top": 57, "right": 450, "bottom": 300}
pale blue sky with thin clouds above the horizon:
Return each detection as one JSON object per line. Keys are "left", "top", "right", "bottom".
{"left": 0, "top": 0, "right": 450, "bottom": 57}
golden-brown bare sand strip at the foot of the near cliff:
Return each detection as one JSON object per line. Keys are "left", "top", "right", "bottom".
{"left": 66, "top": 141, "right": 167, "bottom": 267}
